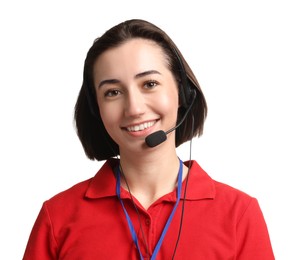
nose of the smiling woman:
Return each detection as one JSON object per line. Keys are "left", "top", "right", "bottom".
{"left": 125, "top": 91, "right": 145, "bottom": 117}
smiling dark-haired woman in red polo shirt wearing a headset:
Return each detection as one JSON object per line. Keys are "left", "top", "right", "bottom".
{"left": 24, "top": 20, "right": 274, "bottom": 260}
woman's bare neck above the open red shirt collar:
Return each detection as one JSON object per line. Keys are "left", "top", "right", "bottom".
{"left": 120, "top": 144, "right": 187, "bottom": 208}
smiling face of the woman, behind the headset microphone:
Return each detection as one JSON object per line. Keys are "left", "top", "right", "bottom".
{"left": 94, "top": 39, "right": 178, "bottom": 153}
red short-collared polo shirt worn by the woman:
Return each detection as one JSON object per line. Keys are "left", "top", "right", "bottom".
{"left": 24, "top": 160, "right": 274, "bottom": 260}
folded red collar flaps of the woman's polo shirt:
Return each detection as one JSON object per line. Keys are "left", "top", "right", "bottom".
{"left": 85, "top": 159, "right": 215, "bottom": 200}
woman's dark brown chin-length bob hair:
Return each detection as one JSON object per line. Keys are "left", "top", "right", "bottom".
{"left": 74, "top": 19, "right": 207, "bottom": 161}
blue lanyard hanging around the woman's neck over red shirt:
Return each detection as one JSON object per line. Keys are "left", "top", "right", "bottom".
{"left": 116, "top": 159, "right": 183, "bottom": 260}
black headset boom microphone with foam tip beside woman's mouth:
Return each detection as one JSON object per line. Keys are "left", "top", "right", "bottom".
{"left": 145, "top": 90, "right": 196, "bottom": 147}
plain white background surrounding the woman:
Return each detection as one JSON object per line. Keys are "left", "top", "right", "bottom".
{"left": 0, "top": 0, "right": 297, "bottom": 260}
